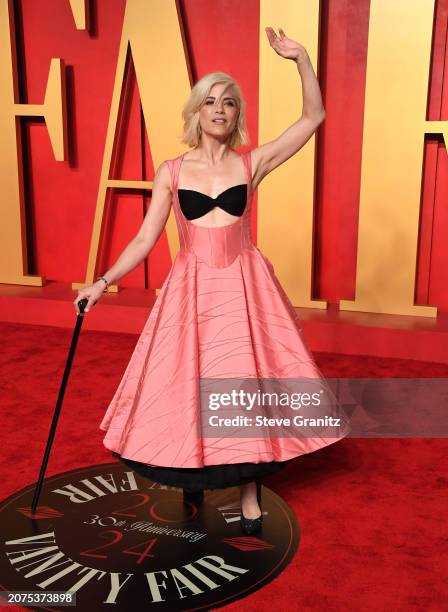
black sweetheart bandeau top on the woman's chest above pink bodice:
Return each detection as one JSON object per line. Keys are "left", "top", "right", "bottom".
{"left": 177, "top": 183, "right": 247, "bottom": 221}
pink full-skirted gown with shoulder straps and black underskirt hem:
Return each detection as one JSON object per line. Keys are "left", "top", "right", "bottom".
{"left": 100, "top": 152, "right": 349, "bottom": 490}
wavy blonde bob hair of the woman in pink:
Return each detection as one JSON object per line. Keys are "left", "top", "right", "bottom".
{"left": 181, "top": 72, "right": 249, "bottom": 148}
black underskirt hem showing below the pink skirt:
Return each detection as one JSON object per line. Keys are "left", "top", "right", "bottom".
{"left": 112, "top": 451, "right": 292, "bottom": 491}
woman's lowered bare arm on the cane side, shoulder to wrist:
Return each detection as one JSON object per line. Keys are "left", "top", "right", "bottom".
{"left": 102, "top": 162, "right": 172, "bottom": 284}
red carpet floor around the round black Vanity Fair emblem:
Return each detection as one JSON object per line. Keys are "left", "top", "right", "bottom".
{"left": 0, "top": 323, "right": 448, "bottom": 612}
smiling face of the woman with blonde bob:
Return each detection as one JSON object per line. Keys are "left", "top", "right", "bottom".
{"left": 199, "top": 83, "right": 239, "bottom": 141}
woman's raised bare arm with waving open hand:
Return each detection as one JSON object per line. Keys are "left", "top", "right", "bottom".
{"left": 251, "top": 27, "right": 325, "bottom": 189}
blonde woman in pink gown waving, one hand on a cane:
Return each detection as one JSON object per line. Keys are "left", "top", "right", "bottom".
{"left": 74, "top": 27, "right": 350, "bottom": 533}
